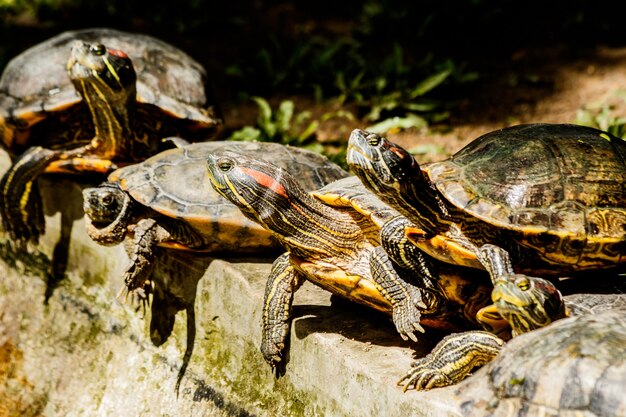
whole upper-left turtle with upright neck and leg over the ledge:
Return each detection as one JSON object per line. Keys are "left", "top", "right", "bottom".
{"left": 0, "top": 28, "right": 222, "bottom": 243}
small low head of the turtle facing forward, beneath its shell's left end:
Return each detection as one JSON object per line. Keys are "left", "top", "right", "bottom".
{"left": 83, "top": 183, "right": 132, "bottom": 245}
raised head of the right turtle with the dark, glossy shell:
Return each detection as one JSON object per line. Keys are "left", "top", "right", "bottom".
{"left": 347, "top": 129, "right": 420, "bottom": 195}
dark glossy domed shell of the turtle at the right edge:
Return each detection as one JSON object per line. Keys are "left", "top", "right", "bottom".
{"left": 423, "top": 124, "right": 626, "bottom": 263}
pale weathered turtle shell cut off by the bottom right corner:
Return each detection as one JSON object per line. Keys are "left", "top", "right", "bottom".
{"left": 451, "top": 292, "right": 626, "bottom": 417}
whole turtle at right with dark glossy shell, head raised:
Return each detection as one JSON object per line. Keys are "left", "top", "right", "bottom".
{"left": 348, "top": 124, "right": 626, "bottom": 282}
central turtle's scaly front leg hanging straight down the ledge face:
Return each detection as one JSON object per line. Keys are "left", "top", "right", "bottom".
{"left": 261, "top": 253, "right": 304, "bottom": 368}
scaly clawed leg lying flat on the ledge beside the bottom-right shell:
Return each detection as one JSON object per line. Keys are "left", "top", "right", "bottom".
{"left": 398, "top": 331, "right": 504, "bottom": 391}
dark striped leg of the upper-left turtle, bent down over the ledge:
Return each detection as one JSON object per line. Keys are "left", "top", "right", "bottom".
{"left": 0, "top": 146, "right": 62, "bottom": 243}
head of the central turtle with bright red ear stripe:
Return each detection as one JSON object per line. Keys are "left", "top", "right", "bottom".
{"left": 207, "top": 151, "right": 306, "bottom": 234}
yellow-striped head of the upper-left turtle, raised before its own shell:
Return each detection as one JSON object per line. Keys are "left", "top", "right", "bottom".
{"left": 67, "top": 41, "right": 137, "bottom": 102}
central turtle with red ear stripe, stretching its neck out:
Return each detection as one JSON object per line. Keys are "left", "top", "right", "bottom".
{"left": 207, "top": 151, "right": 564, "bottom": 367}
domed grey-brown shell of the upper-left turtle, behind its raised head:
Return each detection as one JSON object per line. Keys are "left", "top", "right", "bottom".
{"left": 0, "top": 28, "right": 219, "bottom": 149}
